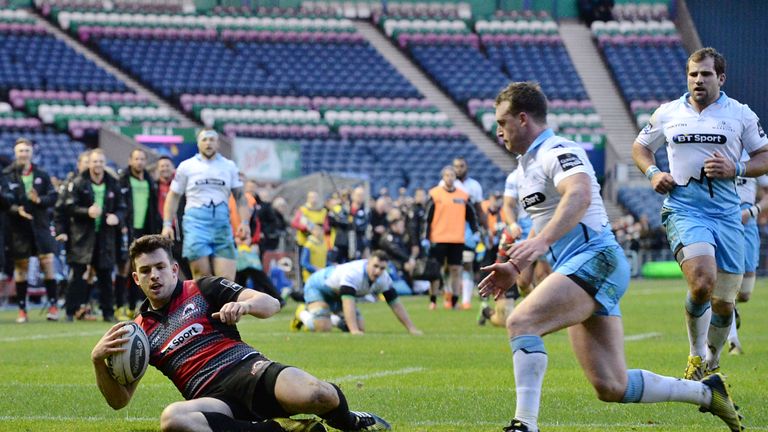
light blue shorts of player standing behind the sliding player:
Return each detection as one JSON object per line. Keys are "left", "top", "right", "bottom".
{"left": 181, "top": 203, "right": 236, "bottom": 261}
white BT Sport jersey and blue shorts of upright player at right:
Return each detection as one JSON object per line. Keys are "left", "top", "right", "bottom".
{"left": 636, "top": 92, "right": 768, "bottom": 274}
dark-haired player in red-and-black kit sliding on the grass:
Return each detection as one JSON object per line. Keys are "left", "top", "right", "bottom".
{"left": 91, "top": 235, "right": 390, "bottom": 432}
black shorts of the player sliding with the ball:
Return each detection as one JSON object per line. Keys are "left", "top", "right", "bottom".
{"left": 199, "top": 354, "right": 291, "bottom": 421}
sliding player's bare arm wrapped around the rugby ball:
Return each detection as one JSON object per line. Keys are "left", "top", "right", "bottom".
{"left": 91, "top": 322, "right": 139, "bottom": 410}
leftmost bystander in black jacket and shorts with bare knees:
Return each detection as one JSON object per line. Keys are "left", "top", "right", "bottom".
{"left": 3, "top": 138, "right": 59, "bottom": 323}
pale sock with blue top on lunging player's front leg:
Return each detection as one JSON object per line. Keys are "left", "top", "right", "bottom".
{"left": 510, "top": 335, "right": 548, "bottom": 430}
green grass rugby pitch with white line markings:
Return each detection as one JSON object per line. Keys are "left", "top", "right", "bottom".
{"left": 0, "top": 280, "right": 768, "bottom": 432}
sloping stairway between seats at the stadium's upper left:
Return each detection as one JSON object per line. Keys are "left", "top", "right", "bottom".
{"left": 30, "top": 13, "right": 201, "bottom": 127}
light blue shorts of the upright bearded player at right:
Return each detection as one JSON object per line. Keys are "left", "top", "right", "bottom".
{"left": 661, "top": 206, "right": 744, "bottom": 274}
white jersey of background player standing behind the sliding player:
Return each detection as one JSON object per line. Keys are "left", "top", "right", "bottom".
{"left": 171, "top": 153, "right": 243, "bottom": 210}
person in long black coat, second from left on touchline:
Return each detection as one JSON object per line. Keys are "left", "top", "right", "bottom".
{"left": 66, "top": 148, "right": 125, "bottom": 321}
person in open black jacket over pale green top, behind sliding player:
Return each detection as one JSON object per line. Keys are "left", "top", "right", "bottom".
{"left": 115, "top": 148, "right": 162, "bottom": 321}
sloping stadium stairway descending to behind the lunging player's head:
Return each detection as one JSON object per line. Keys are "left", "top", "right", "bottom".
{"left": 354, "top": 21, "right": 515, "bottom": 174}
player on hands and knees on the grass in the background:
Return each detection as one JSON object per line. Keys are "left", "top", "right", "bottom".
{"left": 291, "top": 250, "right": 421, "bottom": 335}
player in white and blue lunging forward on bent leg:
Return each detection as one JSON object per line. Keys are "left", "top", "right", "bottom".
{"left": 479, "top": 82, "right": 741, "bottom": 432}
